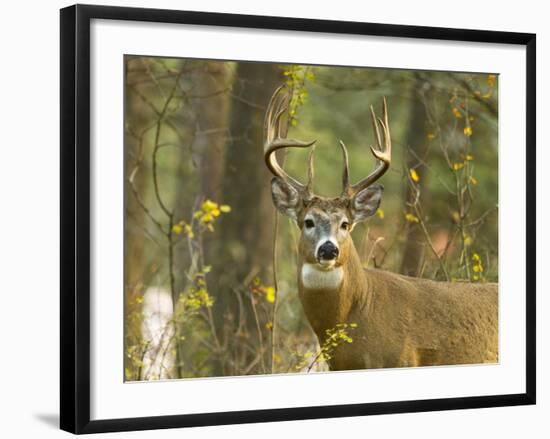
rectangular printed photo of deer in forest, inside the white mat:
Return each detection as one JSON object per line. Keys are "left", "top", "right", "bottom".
{"left": 124, "top": 55, "right": 499, "bottom": 382}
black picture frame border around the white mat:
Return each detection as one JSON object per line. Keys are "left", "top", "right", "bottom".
{"left": 60, "top": 5, "right": 536, "bottom": 434}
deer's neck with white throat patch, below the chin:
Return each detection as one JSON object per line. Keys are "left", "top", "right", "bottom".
{"left": 298, "top": 245, "right": 368, "bottom": 339}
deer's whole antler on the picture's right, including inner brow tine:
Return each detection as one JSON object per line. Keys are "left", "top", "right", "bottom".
{"left": 340, "top": 98, "right": 391, "bottom": 197}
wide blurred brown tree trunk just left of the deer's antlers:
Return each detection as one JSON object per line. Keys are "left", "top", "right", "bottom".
{"left": 209, "top": 63, "right": 283, "bottom": 373}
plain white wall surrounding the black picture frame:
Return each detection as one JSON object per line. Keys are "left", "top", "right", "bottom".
{"left": 0, "top": 0, "right": 550, "bottom": 439}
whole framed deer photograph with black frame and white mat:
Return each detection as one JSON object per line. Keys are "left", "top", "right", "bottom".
{"left": 61, "top": 5, "right": 536, "bottom": 433}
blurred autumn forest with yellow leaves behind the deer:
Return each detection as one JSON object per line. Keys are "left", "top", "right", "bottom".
{"left": 124, "top": 56, "right": 498, "bottom": 381}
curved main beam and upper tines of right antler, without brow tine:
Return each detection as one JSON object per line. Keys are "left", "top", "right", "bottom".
{"left": 350, "top": 98, "right": 391, "bottom": 195}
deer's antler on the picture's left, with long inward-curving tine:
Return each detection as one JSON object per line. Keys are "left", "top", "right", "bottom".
{"left": 264, "top": 85, "right": 316, "bottom": 196}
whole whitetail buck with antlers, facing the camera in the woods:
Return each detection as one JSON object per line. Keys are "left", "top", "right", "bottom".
{"left": 264, "top": 87, "right": 498, "bottom": 370}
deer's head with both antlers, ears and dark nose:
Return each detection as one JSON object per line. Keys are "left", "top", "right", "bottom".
{"left": 264, "top": 86, "right": 391, "bottom": 270}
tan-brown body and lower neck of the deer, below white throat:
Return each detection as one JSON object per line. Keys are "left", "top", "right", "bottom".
{"left": 298, "top": 246, "right": 498, "bottom": 370}
